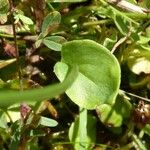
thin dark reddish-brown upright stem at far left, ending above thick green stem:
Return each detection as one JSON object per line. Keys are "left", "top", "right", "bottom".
{"left": 9, "top": 0, "right": 23, "bottom": 91}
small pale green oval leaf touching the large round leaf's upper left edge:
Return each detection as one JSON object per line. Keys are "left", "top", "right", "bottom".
{"left": 43, "top": 38, "right": 62, "bottom": 51}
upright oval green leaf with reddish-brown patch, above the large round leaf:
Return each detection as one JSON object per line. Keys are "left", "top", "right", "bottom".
{"left": 42, "top": 11, "right": 61, "bottom": 36}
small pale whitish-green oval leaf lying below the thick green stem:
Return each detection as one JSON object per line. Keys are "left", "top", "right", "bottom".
{"left": 40, "top": 117, "right": 58, "bottom": 127}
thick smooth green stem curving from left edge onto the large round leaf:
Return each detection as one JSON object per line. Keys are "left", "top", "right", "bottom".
{"left": 0, "top": 65, "right": 78, "bottom": 108}
